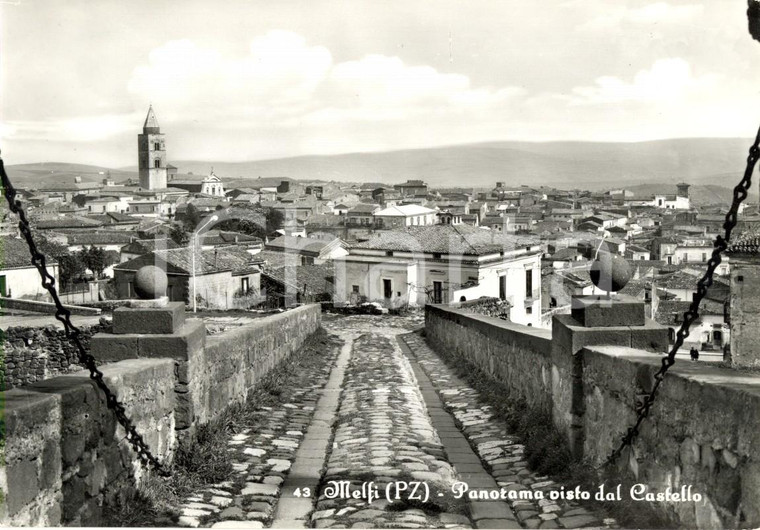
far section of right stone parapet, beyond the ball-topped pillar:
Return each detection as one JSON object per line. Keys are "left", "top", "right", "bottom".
{"left": 425, "top": 304, "right": 552, "bottom": 411}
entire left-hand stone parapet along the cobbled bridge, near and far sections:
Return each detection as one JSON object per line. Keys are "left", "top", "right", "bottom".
{"left": 0, "top": 304, "right": 321, "bottom": 526}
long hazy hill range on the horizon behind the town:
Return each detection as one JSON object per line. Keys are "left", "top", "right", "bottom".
{"left": 12, "top": 138, "right": 751, "bottom": 190}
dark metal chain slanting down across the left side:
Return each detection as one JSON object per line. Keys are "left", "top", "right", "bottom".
{"left": 0, "top": 153, "right": 169, "bottom": 476}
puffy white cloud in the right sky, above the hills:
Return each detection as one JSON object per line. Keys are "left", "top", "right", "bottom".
{"left": 572, "top": 57, "right": 720, "bottom": 104}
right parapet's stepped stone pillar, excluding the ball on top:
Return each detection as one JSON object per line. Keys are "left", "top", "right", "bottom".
{"left": 551, "top": 295, "right": 668, "bottom": 458}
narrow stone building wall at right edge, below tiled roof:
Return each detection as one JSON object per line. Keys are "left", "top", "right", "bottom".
{"left": 726, "top": 252, "right": 760, "bottom": 368}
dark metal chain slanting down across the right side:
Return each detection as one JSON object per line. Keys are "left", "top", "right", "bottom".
{"left": 603, "top": 130, "right": 760, "bottom": 466}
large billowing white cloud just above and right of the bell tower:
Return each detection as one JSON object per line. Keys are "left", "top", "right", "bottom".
{"left": 128, "top": 30, "right": 332, "bottom": 120}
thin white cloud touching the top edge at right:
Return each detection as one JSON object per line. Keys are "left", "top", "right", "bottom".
{"left": 576, "top": 2, "right": 704, "bottom": 31}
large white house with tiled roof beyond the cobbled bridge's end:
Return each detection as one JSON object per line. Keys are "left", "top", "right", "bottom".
{"left": 333, "top": 225, "right": 541, "bottom": 326}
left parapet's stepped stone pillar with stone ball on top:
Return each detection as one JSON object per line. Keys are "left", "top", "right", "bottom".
{"left": 90, "top": 266, "right": 206, "bottom": 431}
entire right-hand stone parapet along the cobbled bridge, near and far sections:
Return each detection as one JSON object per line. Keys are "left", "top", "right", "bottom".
{"left": 425, "top": 305, "right": 760, "bottom": 528}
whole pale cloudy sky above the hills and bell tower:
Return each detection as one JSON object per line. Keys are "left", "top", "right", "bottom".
{"left": 0, "top": 0, "right": 760, "bottom": 167}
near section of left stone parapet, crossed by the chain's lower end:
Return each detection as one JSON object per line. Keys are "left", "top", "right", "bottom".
{"left": 0, "top": 359, "right": 175, "bottom": 526}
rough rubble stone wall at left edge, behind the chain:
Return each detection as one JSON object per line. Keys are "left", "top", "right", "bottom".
{"left": 0, "top": 320, "right": 110, "bottom": 390}
